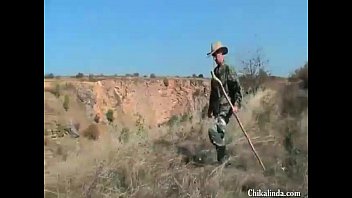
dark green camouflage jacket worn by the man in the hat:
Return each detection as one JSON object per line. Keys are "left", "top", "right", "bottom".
{"left": 208, "top": 64, "right": 242, "bottom": 117}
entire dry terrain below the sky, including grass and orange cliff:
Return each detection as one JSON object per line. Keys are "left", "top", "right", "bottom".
{"left": 44, "top": 69, "right": 308, "bottom": 198}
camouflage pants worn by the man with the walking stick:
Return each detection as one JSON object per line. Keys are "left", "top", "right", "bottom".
{"left": 208, "top": 112, "right": 228, "bottom": 162}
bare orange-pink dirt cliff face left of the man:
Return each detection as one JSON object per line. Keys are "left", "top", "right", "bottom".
{"left": 44, "top": 77, "right": 210, "bottom": 127}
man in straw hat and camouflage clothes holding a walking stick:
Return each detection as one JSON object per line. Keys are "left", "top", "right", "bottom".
{"left": 207, "top": 41, "right": 242, "bottom": 163}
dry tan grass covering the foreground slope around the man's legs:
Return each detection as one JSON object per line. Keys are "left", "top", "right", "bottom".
{"left": 45, "top": 83, "right": 307, "bottom": 198}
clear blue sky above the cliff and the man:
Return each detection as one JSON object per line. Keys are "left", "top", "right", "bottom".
{"left": 44, "top": 0, "right": 308, "bottom": 76}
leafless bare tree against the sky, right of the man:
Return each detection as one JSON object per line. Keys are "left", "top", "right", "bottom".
{"left": 240, "top": 48, "right": 270, "bottom": 92}
